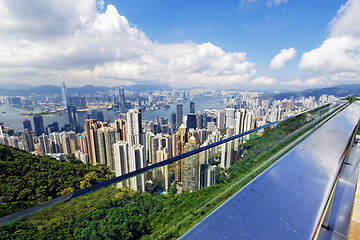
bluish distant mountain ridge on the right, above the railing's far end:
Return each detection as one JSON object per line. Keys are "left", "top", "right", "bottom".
{"left": 262, "top": 84, "right": 360, "bottom": 100}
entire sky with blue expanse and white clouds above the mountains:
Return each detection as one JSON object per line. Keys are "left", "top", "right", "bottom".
{"left": 0, "top": 0, "right": 360, "bottom": 90}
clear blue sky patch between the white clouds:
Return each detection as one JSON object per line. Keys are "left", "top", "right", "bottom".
{"left": 105, "top": 0, "right": 346, "bottom": 88}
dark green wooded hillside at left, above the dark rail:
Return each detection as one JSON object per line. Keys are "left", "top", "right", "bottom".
{"left": 0, "top": 145, "right": 112, "bottom": 217}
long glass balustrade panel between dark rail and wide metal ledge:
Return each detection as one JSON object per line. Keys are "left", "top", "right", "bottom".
{"left": 0, "top": 103, "right": 343, "bottom": 239}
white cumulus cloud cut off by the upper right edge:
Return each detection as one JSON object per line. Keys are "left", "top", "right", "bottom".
{"left": 299, "top": 0, "right": 360, "bottom": 81}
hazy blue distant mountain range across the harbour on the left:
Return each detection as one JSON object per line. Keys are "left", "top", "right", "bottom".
{"left": 0, "top": 84, "right": 172, "bottom": 96}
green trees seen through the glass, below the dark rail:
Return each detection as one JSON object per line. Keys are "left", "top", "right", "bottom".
{"left": 0, "top": 106, "right": 334, "bottom": 239}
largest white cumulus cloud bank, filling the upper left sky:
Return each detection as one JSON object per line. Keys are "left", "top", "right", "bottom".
{"left": 0, "top": 0, "right": 256, "bottom": 87}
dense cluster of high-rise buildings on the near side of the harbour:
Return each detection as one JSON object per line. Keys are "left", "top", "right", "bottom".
{"left": 0, "top": 84, "right": 336, "bottom": 191}
